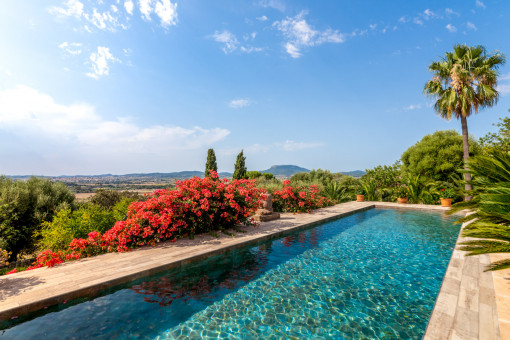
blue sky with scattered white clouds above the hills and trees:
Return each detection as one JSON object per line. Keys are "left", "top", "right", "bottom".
{"left": 0, "top": 0, "right": 510, "bottom": 175}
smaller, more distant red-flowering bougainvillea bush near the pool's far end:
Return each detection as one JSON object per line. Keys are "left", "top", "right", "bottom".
{"left": 273, "top": 181, "right": 333, "bottom": 212}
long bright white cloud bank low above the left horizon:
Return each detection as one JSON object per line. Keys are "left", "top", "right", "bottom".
{"left": 0, "top": 85, "right": 230, "bottom": 156}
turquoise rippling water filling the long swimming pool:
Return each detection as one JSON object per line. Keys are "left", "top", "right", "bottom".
{"left": 0, "top": 209, "right": 460, "bottom": 339}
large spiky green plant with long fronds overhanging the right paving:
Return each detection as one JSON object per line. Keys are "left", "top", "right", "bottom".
{"left": 450, "top": 151, "right": 510, "bottom": 270}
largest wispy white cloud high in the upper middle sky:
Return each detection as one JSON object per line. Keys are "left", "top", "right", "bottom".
{"left": 273, "top": 11, "right": 345, "bottom": 58}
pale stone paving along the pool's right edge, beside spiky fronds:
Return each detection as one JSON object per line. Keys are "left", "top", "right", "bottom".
{"left": 423, "top": 215, "right": 500, "bottom": 340}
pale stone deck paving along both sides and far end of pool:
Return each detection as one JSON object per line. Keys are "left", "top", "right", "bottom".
{"left": 0, "top": 202, "right": 510, "bottom": 340}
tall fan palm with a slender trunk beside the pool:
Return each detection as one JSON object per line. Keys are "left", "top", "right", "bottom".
{"left": 423, "top": 45, "right": 505, "bottom": 200}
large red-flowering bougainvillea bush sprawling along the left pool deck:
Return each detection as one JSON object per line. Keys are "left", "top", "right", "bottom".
{"left": 5, "top": 172, "right": 264, "bottom": 272}
